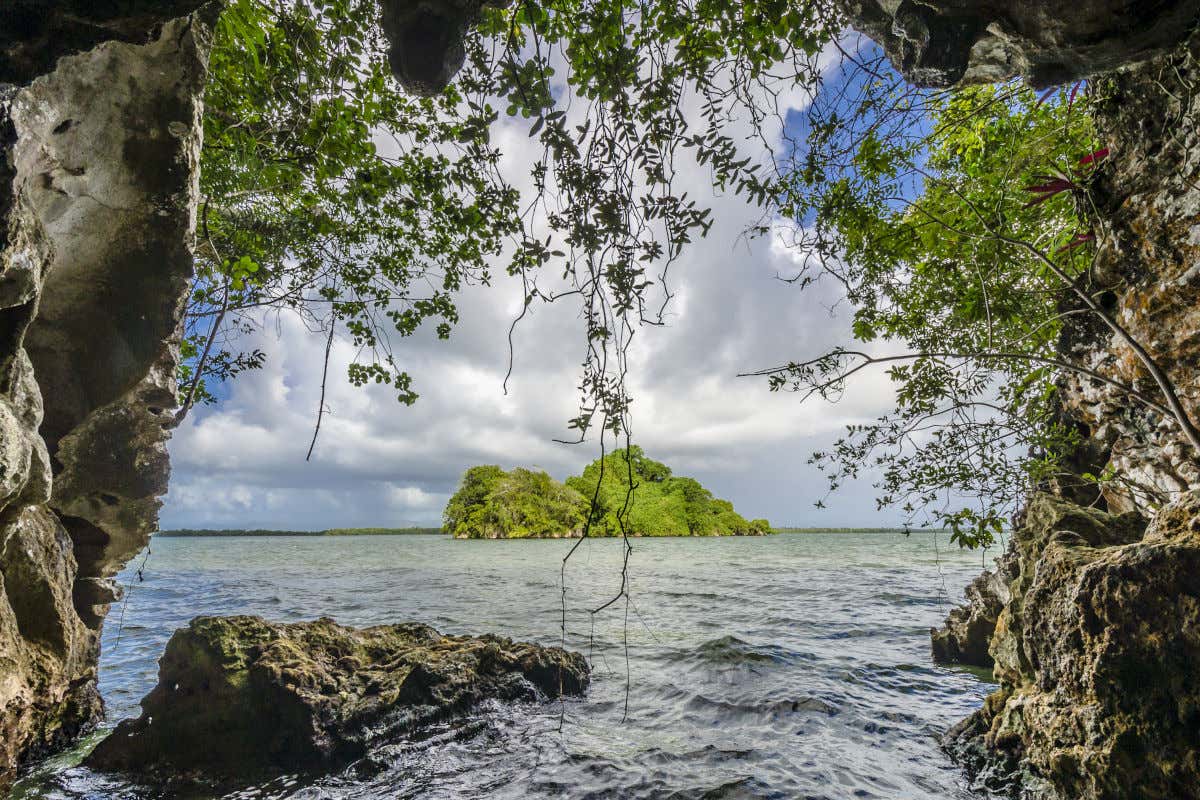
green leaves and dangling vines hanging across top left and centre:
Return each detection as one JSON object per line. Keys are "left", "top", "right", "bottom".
{"left": 181, "top": 0, "right": 841, "bottom": 437}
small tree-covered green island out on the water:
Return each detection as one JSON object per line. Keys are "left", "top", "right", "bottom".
{"left": 443, "top": 446, "right": 773, "bottom": 539}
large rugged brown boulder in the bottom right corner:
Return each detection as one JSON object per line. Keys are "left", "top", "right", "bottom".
{"left": 949, "top": 492, "right": 1200, "bottom": 800}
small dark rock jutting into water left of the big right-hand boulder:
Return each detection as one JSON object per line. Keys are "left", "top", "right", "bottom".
{"left": 929, "top": 542, "right": 1016, "bottom": 668}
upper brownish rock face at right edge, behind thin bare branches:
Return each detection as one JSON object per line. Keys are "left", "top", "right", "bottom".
{"left": 1061, "top": 35, "right": 1200, "bottom": 512}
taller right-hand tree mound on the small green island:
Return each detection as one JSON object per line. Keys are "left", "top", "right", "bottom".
{"left": 566, "top": 446, "right": 770, "bottom": 536}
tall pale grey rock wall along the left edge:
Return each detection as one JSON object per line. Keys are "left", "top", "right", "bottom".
{"left": 0, "top": 0, "right": 216, "bottom": 783}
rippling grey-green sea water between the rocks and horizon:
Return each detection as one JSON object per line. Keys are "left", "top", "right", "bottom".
{"left": 16, "top": 534, "right": 991, "bottom": 800}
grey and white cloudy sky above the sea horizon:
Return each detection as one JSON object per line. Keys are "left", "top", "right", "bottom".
{"left": 162, "top": 42, "right": 899, "bottom": 529}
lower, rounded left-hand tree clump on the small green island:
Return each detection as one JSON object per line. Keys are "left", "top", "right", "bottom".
{"left": 442, "top": 465, "right": 587, "bottom": 539}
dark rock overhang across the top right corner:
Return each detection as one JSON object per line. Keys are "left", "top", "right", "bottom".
{"left": 840, "top": 0, "right": 1200, "bottom": 86}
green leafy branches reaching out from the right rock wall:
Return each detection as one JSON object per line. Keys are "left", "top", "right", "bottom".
{"left": 770, "top": 85, "right": 1097, "bottom": 546}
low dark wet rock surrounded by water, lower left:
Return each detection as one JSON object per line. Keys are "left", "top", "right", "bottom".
{"left": 85, "top": 616, "right": 588, "bottom": 781}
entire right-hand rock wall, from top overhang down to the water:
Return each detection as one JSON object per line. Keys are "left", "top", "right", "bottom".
{"left": 846, "top": 0, "right": 1200, "bottom": 800}
